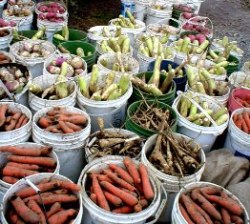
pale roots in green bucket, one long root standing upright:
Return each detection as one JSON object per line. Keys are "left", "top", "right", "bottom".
{"left": 131, "top": 57, "right": 175, "bottom": 96}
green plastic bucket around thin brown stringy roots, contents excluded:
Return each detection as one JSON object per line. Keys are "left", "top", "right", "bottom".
{"left": 125, "top": 100, "right": 177, "bottom": 138}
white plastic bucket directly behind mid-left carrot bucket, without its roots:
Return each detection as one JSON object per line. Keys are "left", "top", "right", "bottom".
{"left": 29, "top": 75, "right": 77, "bottom": 112}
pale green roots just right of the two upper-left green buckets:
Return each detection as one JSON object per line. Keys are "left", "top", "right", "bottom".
{"left": 100, "top": 35, "right": 131, "bottom": 54}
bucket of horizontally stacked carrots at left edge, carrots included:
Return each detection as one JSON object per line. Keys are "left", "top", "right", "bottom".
{"left": 0, "top": 142, "right": 60, "bottom": 197}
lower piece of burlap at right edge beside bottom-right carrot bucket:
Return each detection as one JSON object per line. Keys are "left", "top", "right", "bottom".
{"left": 227, "top": 178, "right": 250, "bottom": 215}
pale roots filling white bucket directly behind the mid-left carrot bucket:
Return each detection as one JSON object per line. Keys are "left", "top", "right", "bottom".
{"left": 29, "top": 72, "right": 75, "bottom": 100}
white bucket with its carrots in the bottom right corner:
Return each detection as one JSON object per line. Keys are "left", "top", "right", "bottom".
{"left": 172, "top": 182, "right": 250, "bottom": 224}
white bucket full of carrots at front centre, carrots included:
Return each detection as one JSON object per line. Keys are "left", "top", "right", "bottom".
{"left": 78, "top": 156, "right": 166, "bottom": 224}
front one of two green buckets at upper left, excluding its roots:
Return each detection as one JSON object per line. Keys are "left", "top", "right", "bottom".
{"left": 60, "top": 40, "right": 96, "bottom": 68}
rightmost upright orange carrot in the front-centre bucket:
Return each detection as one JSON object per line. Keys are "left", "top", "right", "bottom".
{"left": 139, "top": 163, "right": 155, "bottom": 201}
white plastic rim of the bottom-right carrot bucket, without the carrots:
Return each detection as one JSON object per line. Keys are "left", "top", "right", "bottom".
{"left": 172, "top": 182, "right": 250, "bottom": 224}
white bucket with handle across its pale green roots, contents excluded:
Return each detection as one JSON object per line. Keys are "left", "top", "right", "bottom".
{"left": 172, "top": 93, "right": 229, "bottom": 153}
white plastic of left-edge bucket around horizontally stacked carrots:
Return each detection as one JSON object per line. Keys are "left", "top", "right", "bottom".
{"left": 0, "top": 142, "right": 60, "bottom": 202}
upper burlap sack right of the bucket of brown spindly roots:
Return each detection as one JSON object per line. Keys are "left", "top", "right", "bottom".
{"left": 202, "top": 149, "right": 250, "bottom": 187}
